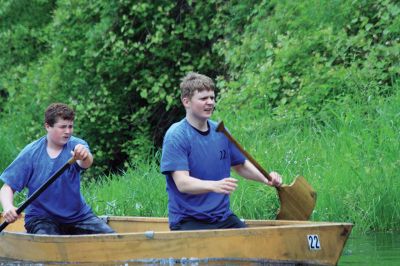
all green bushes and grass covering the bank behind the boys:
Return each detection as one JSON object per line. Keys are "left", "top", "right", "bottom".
{"left": 0, "top": 0, "right": 400, "bottom": 230}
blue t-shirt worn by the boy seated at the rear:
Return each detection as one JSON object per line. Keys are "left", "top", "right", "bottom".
{"left": 0, "top": 136, "right": 92, "bottom": 223}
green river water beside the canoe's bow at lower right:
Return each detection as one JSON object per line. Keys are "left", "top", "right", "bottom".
{"left": 0, "top": 233, "right": 400, "bottom": 266}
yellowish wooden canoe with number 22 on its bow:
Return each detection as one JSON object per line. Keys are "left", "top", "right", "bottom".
{"left": 0, "top": 217, "right": 352, "bottom": 265}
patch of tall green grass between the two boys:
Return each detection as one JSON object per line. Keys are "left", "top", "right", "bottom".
{"left": 83, "top": 155, "right": 167, "bottom": 217}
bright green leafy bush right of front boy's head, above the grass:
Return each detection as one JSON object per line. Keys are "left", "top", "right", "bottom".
{"left": 218, "top": 0, "right": 400, "bottom": 117}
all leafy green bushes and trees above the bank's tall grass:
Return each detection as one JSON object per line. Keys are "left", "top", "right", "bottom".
{"left": 0, "top": 0, "right": 400, "bottom": 175}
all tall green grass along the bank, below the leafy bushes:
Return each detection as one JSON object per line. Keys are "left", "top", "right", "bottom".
{"left": 79, "top": 90, "right": 400, "bottom": 232}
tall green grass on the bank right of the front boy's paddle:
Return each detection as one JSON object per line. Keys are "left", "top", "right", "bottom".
{"left": 217, "top": 90, "right": 400, "bottom": 231}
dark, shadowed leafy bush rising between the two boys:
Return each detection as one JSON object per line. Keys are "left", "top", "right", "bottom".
{"left": 65, "top": 1, "right": 228, "bottom": 171}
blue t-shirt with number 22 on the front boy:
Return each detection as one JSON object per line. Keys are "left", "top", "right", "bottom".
{"left": 161, "top": 118, "right": 245, "bottom": 226}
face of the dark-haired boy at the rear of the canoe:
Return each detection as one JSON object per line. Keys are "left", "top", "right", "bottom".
{"left": 45, "top": 118, "right": 74, "bottom": 146}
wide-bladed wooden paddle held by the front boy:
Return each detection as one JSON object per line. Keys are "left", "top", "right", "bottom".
{"left": 217, "top": 121, "right": 317, "bottom": 220}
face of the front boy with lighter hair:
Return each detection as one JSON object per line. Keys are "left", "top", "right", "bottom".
{"left": 182, "top": 90, "right": 215, "bottom": 120}
